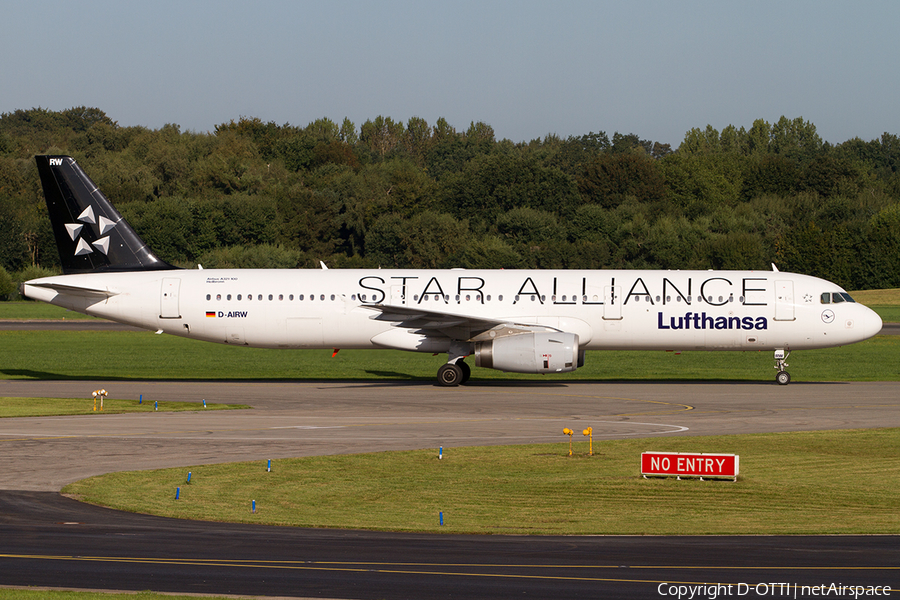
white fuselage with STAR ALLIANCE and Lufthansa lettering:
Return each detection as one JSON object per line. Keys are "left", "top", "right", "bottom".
{"left": 25, "top": 269, "right": 881, "bottom": 352}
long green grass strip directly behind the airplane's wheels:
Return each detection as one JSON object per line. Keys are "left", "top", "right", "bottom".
{"left": 0, "top": 331, "right": 900, "bottom": 383}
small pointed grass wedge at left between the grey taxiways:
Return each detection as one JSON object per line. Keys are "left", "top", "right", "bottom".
{"left": 0, "top": 397, "right": 250, "bottom": 418}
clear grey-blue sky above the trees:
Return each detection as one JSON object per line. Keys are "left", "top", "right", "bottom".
{"left": 0, "top": 0, "right": 900, "bottom": 147}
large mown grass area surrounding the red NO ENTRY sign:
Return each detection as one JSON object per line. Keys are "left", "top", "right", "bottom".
{"left": 63, "top": 429, "right": 900, "bottom": 535}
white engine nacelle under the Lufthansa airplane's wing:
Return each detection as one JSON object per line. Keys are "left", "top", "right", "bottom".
{"left": 475, "top": 331, "right": 584, "bottom": 373}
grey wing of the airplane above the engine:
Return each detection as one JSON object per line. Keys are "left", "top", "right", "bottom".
{"left": 361, "top": 304, "right": 558, "bottom": 341}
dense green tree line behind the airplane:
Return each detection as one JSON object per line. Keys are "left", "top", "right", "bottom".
{"left": 0, "top": 107, "right": 900, "bottom": 294}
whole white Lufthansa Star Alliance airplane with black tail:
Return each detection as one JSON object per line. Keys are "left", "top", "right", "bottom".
{"left": 22, "top": 156, "right": 882, "bottom": 386}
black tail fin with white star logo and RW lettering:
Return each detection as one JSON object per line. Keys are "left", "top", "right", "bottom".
{"left": 35, "top": 156, "right": 176, "bottom": 275}
